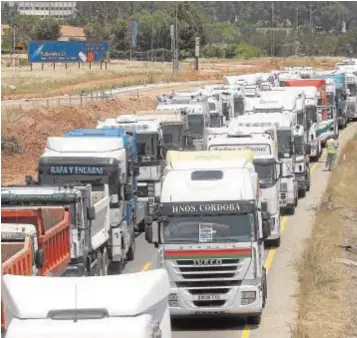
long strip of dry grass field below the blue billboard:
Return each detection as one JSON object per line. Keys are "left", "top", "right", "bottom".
{"left": 1, "top": 57, "right": 340, "bottom": 99}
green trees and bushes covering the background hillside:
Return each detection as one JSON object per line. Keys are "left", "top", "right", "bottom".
{"left": 1, "top": 1, "right": 357, "bottom": 58}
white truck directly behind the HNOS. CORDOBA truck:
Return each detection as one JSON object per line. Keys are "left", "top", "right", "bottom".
{"left": 207, "top": 121, "right": 281, "bottom": 247}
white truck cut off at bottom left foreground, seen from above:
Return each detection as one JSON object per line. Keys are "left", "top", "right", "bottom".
{"left": 2, "top": 269, "right": 171, "bottom": 338}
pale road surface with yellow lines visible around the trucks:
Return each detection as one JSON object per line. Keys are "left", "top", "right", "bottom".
{"left": 124, "top": 123, "right": 357, "bottom": 338}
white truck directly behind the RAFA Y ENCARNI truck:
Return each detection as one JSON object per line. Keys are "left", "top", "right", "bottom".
{"left": 96, "top": 115, "right": 164, "bottom": 230}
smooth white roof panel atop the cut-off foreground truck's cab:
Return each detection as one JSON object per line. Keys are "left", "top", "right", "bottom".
{"left": 2, "top": 269, "right": 170, "bottom": 319}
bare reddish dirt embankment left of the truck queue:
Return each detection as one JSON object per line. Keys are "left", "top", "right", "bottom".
{"left": 1, "top": 95, "right": 157, "bottom": 184}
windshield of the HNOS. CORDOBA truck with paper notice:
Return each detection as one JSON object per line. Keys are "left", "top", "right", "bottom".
{"left": 163, "top": 213, "right": 254, "bottom": 244}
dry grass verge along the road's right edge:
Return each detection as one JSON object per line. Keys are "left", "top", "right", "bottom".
{"left": 292, "top": 135, "right": 357, "bottom": 338}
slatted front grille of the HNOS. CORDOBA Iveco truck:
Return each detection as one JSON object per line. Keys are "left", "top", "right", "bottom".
{"left": 171, "top": 258, "right": 243, "bottom": 308}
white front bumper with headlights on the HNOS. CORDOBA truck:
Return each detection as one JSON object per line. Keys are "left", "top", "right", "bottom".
{"left": 169, "top": 285, "right": 263, "bottom": 317}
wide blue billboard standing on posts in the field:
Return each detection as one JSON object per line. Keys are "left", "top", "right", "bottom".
{"left": 28, "top": 41, "right": 109, "bottom": 63}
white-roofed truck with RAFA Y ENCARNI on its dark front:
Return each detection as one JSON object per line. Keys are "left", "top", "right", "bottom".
{"left": 38, "top": 135, "right": 135, "bottom": 271}
